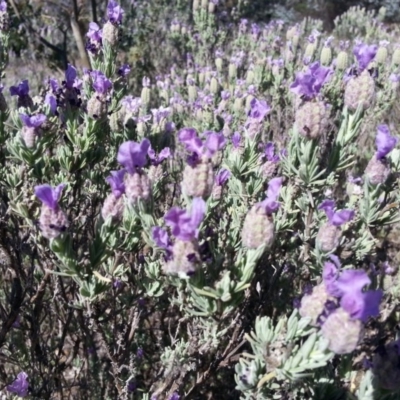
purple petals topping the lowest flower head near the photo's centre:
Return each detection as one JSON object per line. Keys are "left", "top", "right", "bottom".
{"left": 164, "top": 197, "right": 206, "bottom": 242}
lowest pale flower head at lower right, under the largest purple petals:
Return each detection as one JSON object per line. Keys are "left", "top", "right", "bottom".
{"left": 321, "top": 308, "right": 364, "bottom": 354}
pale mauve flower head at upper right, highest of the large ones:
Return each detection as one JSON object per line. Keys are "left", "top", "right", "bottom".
{"left": 344, "top": 70, "right": 375, "bottom": 111}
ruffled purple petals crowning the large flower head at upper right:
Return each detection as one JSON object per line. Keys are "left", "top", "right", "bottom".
{"left": 290, "top": 62, "right": 332, "bottom": 100}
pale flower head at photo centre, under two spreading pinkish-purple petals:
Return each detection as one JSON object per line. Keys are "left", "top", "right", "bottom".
{"left": 182, "top": 159, "right": 214, "bottom": 199}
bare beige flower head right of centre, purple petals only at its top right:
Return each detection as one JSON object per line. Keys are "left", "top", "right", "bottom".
{"left": 242, "top": 204, "right": 275, "bottom": 249}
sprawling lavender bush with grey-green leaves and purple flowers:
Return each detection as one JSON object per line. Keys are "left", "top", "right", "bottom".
{"left": 0, "top": 0, "right": 400, "bottom": 400}
